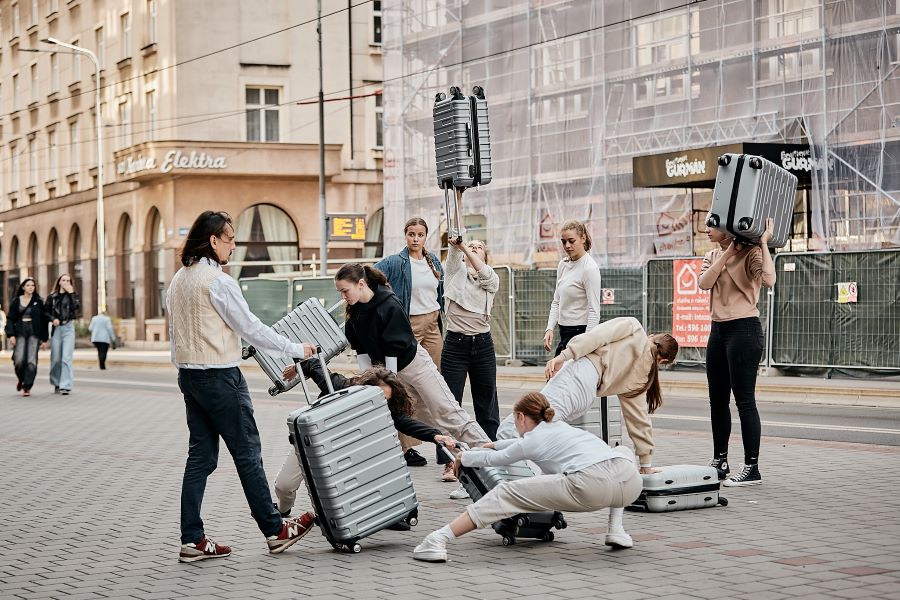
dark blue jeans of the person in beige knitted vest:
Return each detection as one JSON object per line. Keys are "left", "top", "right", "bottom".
{"left": 178, "top": 367, "right": 282, "bottom": 544}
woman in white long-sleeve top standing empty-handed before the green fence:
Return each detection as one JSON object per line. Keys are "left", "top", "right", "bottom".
{"left": 544, "top": 221, "right": 602, "bottom": 356}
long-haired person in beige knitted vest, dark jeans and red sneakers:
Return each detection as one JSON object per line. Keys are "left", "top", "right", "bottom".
{"left": 166, "top": 211, "right": 315, "bottom": 562}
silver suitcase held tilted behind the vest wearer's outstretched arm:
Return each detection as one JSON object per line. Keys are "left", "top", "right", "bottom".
{"left": 242, "top": 298, "right": 349, "bottom": 396}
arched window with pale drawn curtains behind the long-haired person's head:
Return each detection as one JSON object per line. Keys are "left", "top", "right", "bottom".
{"left": 230, "top": 204, "right": 300, "bottom": 278}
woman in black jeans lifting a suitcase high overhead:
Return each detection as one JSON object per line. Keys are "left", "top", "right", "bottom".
{"left": 438, "top": 190, "right": 500, "bottom": 492}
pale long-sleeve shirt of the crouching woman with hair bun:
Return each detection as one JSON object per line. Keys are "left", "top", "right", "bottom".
{"left": 461, "top": 421, "right": 621, "bottom": 473}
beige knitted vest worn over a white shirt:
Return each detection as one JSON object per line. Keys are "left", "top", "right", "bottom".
{"left": 171, "top": 263, "right": 241, "bottom": 365}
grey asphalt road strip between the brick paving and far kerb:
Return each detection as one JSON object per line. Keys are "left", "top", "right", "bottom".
{"left": 7, "top": 365, "right": 900, "bottom": 446}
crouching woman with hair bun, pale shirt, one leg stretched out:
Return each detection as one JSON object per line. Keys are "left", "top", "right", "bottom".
{"left": 413, "top": 392, "right": 642, "bottom": 562}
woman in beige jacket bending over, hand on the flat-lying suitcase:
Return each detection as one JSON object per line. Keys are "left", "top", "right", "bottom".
{"left": 497, "top": 317, "right": 678, "bottom": 547}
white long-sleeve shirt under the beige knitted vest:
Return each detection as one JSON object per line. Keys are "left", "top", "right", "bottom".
{"left": 166, "top": 258, "right": 313, "bottom": 369}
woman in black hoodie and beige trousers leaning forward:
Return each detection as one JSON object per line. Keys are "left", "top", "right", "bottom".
{"left": 334, "top": 263, "right": 491, "bottom": 446}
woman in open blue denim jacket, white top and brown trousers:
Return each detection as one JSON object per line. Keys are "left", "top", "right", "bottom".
{"left": 375, "top": 217, "right": 444, "bottom": 467}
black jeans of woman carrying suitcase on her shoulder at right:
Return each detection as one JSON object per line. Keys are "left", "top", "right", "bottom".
{"left": 706, "top": 317, "right": 765, "bottom": 464}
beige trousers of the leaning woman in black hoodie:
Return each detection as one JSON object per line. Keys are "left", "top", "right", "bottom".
{"left": 397, "top": 345, "right": 491, "bottom": 446}
